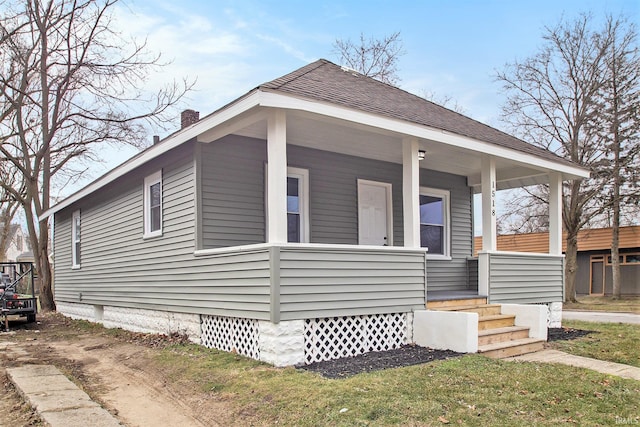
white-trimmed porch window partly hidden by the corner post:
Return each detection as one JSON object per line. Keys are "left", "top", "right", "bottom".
{"left": 287, "top": 167, "right": 309, "bottom": 243}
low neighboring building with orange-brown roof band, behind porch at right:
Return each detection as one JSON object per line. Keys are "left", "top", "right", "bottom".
{"left": 475, "top": 226, "right": 640, "bottom": 295}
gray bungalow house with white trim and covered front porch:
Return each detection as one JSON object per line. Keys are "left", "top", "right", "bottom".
{"left": 44, "top": 60, "right": 588, "bottom": 366}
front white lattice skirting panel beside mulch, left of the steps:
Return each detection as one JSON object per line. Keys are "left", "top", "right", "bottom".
{"left": 304, "top": 313, "right": 410, "bottom": 364}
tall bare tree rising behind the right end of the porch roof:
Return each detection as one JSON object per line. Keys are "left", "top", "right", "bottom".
{"left": 497, "top": 15, "right": 624, "bottom": 301}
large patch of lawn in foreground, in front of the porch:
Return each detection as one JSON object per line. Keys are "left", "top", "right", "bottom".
{"left": 154, "top": 345, "right": 640, "bottom": 426}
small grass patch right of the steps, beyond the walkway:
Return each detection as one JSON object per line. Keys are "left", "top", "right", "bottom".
{"left": 549, "top": 320, "right": 640, "bottom": 368}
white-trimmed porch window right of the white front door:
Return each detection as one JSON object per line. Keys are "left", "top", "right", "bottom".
{"left": 420, "top": 187, "right": 451, "bottom": 258}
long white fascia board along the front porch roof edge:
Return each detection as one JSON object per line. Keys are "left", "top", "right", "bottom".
{"left": 260, "top": 91, "right": 589, "bottom": 178}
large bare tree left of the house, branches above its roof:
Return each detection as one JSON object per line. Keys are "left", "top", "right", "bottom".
{"left": 0, "top": 0, "right": 190, "bottom": 309}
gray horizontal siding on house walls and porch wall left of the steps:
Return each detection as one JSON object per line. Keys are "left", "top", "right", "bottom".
{"left": 55, "top": 136, "right": 472, "bottom": 320}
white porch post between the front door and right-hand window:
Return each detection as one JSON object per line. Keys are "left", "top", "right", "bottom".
{"left": 402, "top": 138, "right": 420, "bottom": 248}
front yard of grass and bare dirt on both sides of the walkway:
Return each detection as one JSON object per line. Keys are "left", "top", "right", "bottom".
{"left": 0, "top": 314, "right": 640, "bottom": 426}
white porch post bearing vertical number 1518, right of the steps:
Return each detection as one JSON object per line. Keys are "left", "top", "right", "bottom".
{"left": 478, "top": 156, "right": 498, "bottom": 297}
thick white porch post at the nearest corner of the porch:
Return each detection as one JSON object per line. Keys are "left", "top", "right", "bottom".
{"left": 265, "top": 110, "right": 287, "bottom": 243}
